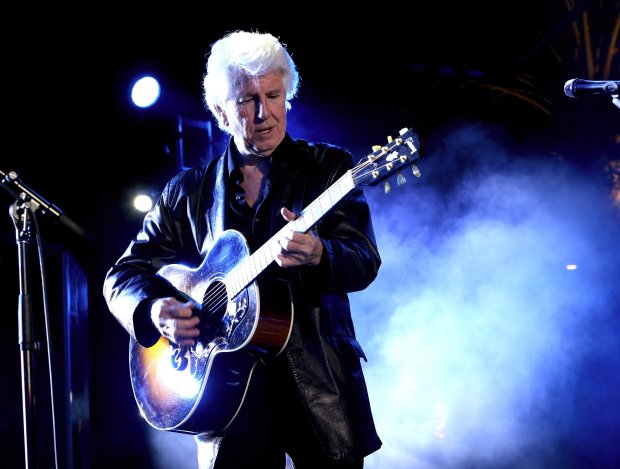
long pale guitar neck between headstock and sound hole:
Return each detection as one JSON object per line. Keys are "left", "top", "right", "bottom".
{"left": 226, "top": 170, "right": 356, "bottom": 297}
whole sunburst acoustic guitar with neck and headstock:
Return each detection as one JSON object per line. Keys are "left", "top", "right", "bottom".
{"left": 129, "top": 128, "right": 420, "bottom": 435}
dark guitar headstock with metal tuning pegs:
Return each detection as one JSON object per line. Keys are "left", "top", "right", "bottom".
{"left": 351, "top": 128, "right": 421, "bottom": 192}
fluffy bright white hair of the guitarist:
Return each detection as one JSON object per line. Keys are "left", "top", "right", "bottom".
{"left": 203, "top": 31, "right": 299, "bottom": 131}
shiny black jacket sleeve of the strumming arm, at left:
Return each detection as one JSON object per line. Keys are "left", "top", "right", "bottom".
{"left": 103, "top": 170, "right": 203, "bottom": 347}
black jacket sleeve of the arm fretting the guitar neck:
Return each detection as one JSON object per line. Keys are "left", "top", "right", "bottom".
{"left": 305, "top": 145, "right": 381, "bottom": 293}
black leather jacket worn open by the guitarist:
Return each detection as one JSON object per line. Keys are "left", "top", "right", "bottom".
{"left": 104, "top": 135, "right": 381, "bottom": 461}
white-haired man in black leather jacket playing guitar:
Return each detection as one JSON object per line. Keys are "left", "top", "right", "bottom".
{"left": 104, "top": 31, "right": 381, "bottom": 469}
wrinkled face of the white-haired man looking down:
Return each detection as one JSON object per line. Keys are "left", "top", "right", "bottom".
{"left": 217, "top": 72, "right": 286, "bottom": 156}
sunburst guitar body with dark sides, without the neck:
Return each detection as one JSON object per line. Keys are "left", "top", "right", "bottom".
{"left": 129, "top": 230, "right": 293, "bottom": 434}
